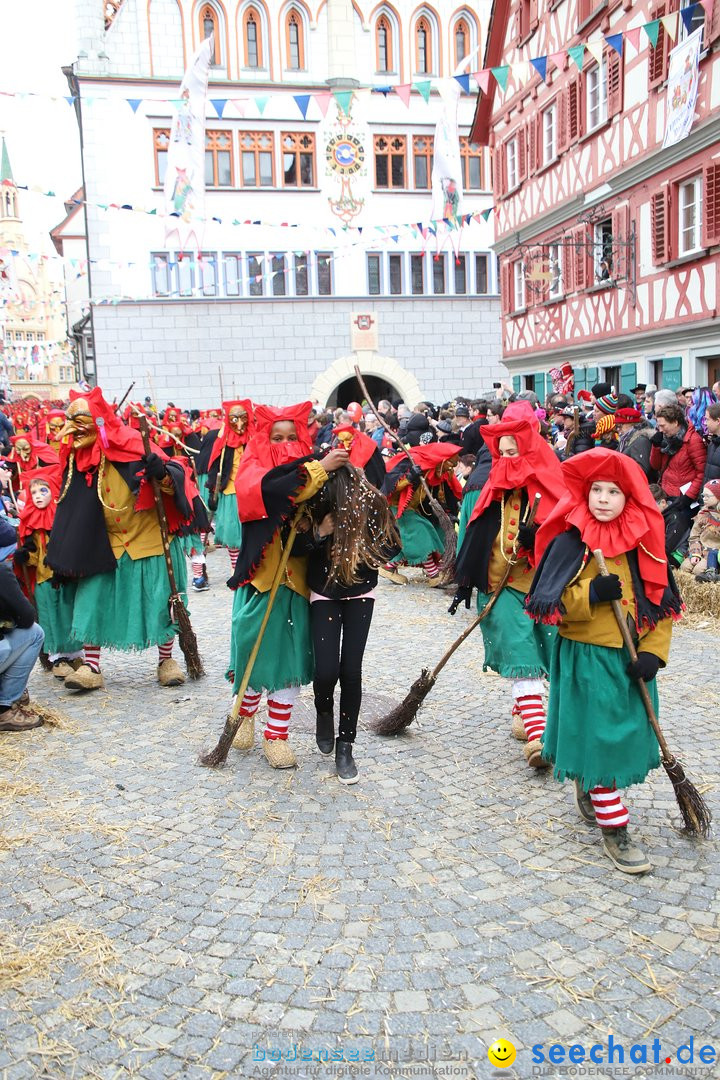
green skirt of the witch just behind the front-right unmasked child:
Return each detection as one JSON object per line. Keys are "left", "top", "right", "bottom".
{"left": 477, "top": 585, "right": 557, "bottom": 678}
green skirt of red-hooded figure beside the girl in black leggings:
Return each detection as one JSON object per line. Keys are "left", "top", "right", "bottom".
{"left": 228, "top": 585, "right": 315, "bottom": 693}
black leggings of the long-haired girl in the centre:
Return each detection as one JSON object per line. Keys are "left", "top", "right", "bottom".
{"left": 310, "top": 599, "right": 375, "bottom": 742}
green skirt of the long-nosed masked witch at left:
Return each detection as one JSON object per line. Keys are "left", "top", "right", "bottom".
{"left": 63, "top": 540, "right": 188, "bottom": 651}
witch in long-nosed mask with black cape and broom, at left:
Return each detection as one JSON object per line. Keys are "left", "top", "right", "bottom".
{"left": 46, "top": 387, "right": 193, "bottom": 690}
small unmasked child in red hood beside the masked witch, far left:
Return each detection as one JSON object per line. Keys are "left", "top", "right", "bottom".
{"left": 14, "top": 465, "right": 82, "bottom": 678}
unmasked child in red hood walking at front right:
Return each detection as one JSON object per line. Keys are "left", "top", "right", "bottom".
{"left": 527, "top": 448, "right": 681, "bottom": 874}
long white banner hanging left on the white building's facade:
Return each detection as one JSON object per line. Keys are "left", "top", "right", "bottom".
{"left": 164, "top": 35, "right": 214, "bottom": 251}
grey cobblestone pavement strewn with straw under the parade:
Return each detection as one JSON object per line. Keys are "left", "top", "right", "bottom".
{"left": 0, "top": 552, "right": 720, "bottom": 1080}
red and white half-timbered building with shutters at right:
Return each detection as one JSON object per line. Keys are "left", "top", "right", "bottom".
{"left": 471, "top": 0, "right": 720, "bottom": 396}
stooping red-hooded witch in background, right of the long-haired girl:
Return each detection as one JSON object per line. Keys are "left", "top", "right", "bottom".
{"left": 380, "top": 443, "right": 462, "bottom": 588}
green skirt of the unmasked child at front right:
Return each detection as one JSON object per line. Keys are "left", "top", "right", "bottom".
{"left": 543, "top": 635, "right": 660, "bottom": 791}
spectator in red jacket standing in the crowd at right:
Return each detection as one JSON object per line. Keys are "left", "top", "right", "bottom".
{"left": 650, "top": 405, "right": 707, "bottom": 553}
